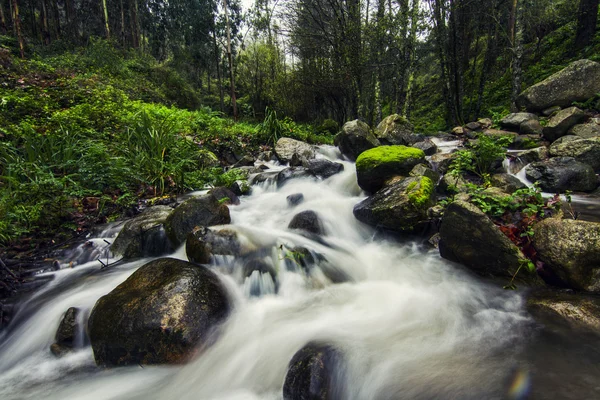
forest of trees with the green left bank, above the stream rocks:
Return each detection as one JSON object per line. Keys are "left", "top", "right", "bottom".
{"left": 0, "top": 0, "right": 600, "bottom": 243}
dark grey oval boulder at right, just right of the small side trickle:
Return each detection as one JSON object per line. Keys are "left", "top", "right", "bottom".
{"left": 525, "top": 157, "right": 598, "bottom": 193}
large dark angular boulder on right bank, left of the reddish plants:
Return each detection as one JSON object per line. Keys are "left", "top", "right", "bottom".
{"left": 439, "top": 201, "right": 541, "bottom": 284}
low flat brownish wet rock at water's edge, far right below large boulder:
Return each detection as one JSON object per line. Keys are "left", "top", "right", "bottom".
{"left": 527, "top": 291, "right": 600, "bottom": 332}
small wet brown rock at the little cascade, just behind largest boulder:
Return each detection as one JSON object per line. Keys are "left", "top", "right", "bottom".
{"left": 185, "top": 226, "right": 242, "bottom": 264}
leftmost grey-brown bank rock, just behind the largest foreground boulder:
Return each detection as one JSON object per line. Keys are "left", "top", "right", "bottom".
{"left": 110, "top": 206, "right": 173, "bottom": 259}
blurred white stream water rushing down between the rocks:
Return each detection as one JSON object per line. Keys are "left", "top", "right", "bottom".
{"left": 0, "top": 148, "right": 600, "bottom": 400}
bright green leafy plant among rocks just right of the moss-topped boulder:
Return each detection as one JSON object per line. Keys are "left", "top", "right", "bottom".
{"left": 450, "top": 134, "right": 513, "bottom": 180}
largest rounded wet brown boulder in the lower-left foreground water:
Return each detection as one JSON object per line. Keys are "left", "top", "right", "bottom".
{"left": 88, "top": 258, "right": 231, "bottom": 366}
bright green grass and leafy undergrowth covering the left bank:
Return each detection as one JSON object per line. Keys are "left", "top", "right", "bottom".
{"left": 0, "top": 40, "right": 332, "bottom": 244}
